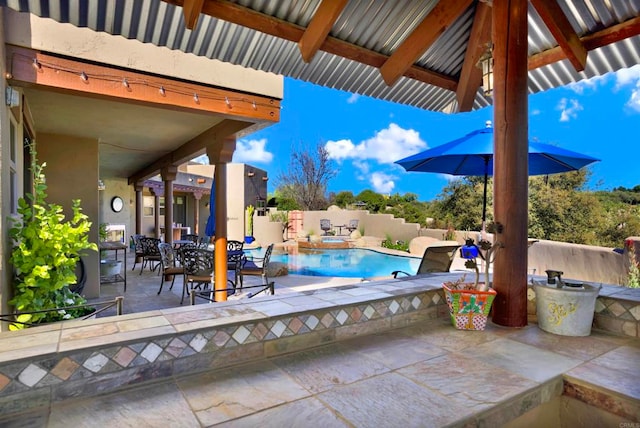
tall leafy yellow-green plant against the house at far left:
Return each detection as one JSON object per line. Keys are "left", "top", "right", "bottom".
{"left": 9, "top": 150, "right": 97, "bottom": 330}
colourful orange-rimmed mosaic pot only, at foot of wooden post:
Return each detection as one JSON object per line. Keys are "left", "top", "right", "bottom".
{"left": 442, "top": 285, "right": 498, "bottom": 330}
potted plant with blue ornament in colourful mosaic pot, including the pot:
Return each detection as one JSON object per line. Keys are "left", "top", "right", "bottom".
{"left": 442, "top": 239, "right": 502, "bottom": 330}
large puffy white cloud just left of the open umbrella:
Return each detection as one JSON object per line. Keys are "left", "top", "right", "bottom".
{"left": 325, "top": 123, "right": 427, "bottom": 164}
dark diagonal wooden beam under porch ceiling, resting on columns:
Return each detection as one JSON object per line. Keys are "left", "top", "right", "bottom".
{"left": 128, "top": 119, "right": 252, "bottom": 184}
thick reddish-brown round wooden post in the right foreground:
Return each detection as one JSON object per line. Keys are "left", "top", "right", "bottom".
{"left": 492, "top": 0, "right": 529, "bottom": 327}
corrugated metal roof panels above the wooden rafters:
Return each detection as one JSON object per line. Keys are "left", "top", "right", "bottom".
{"left": 0, "top": 0, "right": 640, "bottom": 111}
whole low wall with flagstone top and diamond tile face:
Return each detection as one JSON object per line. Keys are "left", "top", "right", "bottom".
{"left": 0, "top": 274, "right": 640, "bottom": 415}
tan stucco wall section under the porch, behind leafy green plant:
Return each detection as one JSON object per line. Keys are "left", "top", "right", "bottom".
{"left": 37, "top": 133, "right": 99, "bottom": 298}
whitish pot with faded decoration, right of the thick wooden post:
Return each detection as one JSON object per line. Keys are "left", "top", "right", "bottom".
{"left": 533, "top": 284, "right": 602, "bottom": 336}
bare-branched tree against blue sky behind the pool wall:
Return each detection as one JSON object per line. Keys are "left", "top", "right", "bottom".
{"left": 278, "top": 143, "right": 337, "bottom": 211}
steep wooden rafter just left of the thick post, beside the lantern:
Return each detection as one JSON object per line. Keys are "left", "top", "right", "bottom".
{"left": 456, "top": 2, "right": 491, "bottom": 112}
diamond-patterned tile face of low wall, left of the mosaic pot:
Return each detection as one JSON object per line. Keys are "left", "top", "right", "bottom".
{"left": 0, "top": 290, "right": 447, "bottom": 415}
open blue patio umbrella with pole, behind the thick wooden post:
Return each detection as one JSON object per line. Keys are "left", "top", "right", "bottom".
{"left": 395, "top": 123, "right": 600, "bottom": 229}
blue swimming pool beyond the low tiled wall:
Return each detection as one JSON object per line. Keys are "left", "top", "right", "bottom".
{"left": 245, "top": 248, "right": 420, "bottom": 278}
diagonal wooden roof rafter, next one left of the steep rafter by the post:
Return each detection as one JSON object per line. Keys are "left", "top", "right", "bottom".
{"left": 380, "top": 0, "right": 472, "bottom": 86}
